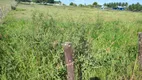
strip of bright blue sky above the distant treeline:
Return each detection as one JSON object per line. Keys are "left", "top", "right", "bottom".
{"left": 57, "top": 0, "right": 142, "bottom": 5}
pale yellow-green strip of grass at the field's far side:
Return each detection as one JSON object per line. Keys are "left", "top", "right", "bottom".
{"left": 12, "top": 5, "right": 142, "bottom": 22}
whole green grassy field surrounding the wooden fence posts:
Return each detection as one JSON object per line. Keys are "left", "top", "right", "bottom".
{"left": 0, "top": 4, "right": 142, "bottom": 80}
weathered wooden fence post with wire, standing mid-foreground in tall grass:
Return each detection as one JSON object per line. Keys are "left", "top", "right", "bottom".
{"left": 63, "top": 42, "right": 75, "bottom": 80}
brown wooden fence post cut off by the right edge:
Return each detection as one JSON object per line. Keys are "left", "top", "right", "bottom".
{"left": 138, "top": 32, "right": 142, "bottom": 70}
